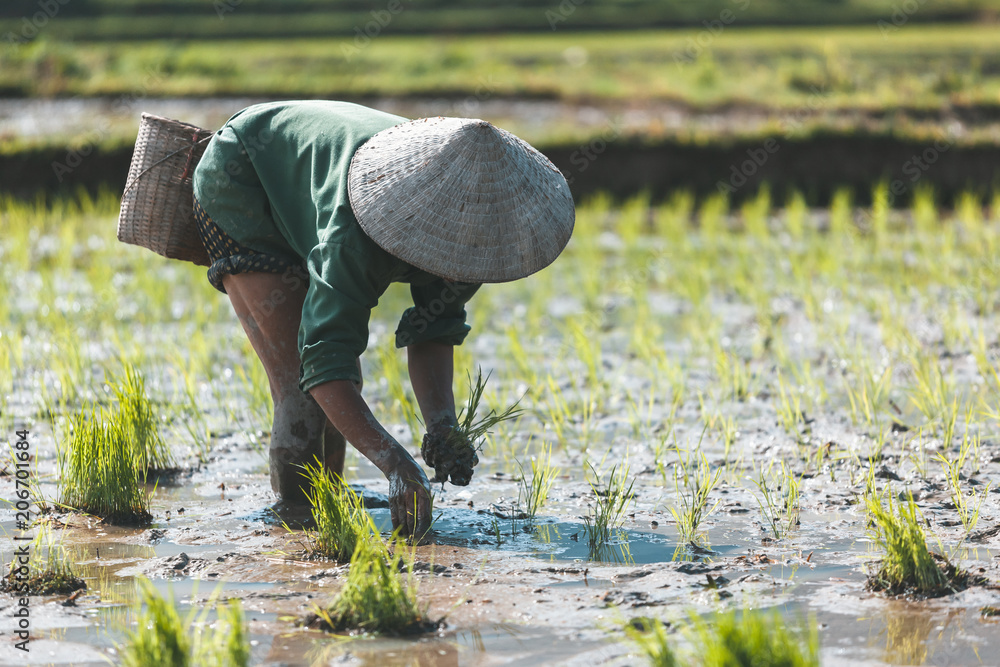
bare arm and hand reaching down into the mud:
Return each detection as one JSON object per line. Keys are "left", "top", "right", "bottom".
{"left": 309, "top": 380, "right": 431, "bottom": 537}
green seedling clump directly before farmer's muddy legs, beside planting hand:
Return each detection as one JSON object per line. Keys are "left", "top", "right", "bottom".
{"left": 303, "top": 461, "right": 379, "bottom": 563}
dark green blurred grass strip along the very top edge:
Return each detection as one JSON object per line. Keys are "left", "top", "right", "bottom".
{"left": 0, "top": 0, "right": 1000, "bottom": 40}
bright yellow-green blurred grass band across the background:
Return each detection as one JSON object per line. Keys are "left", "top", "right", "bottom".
{"left": 0, "top": 23, "right": 1000, "bottom": 110}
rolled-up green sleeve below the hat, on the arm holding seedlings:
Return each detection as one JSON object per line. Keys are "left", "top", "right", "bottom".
{"left": 396, "top": 278, "right": 480, "bottom": 347}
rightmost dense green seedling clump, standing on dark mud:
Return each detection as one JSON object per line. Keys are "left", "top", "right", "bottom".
{"left": 865, "top": 493, "right": 952, "bottom": 596}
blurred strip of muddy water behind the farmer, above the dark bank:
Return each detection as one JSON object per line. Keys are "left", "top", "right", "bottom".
{"left": 0, "top": 94, "right": 976, "bottom": 144}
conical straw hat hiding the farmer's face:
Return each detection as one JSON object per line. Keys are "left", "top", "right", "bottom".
{"left": 348, "top": 117, "right": 576, "bottom": 283}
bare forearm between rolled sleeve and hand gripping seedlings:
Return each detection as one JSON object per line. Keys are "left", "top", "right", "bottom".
{"left": 406, "top": 341, "right": 458, "bottom": 435}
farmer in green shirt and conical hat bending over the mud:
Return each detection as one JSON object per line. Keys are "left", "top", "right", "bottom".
{"left": 194, "top": 101, "right": 574, "bottom": 536}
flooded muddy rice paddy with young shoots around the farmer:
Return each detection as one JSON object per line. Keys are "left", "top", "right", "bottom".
{"left": 0, "top": 192, "right": 1000, "bottom": 666}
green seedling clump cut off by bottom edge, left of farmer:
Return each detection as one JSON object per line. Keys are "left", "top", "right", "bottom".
{"left": 118, "top": 578, "right": 250, "bottom": 667}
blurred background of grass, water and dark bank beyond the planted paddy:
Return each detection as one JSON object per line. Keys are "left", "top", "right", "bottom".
{"left": 0, "top": 0, "right": 1000, "bottom": 205}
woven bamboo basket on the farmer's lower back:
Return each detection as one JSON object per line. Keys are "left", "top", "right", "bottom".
{"left": 118, "top": 113, "right": 213, "bottom": 266}
